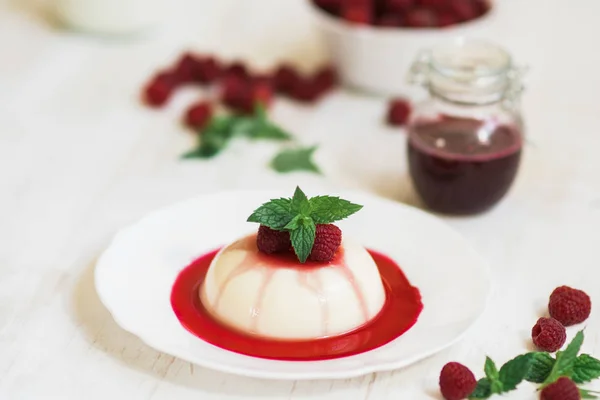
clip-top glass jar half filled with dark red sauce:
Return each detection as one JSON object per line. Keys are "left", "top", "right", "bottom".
{"left": 407, "top": 39, "right": 524, "bottom": 215}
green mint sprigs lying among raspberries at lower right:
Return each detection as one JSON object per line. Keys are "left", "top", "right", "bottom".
{"left": 469, "top": 331, "right": 600, "bottom": 399}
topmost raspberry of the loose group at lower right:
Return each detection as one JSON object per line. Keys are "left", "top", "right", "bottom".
{"left": 548, "top": 286, "right": 592, "bottom": 326}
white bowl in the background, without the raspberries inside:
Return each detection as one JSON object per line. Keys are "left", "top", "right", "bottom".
{"left": 307, "top": 0, "right": 500, "bottom": 96}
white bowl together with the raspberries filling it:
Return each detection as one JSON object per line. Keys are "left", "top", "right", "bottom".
{"left": 307, "top": 0, "right": 501, "bottom": 96}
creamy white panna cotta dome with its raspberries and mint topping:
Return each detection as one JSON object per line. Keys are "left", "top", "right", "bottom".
{"left": 199, "top": 188, "right": 386, "bottom": 340}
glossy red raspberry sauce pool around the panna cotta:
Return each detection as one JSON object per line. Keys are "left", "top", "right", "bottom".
{"left": 171, "top": 250, "right": 423, "bottom": 361}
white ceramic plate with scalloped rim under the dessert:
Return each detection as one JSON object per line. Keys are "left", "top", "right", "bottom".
{"left": 95, "top": 191, "right": 490, "bottom": 379}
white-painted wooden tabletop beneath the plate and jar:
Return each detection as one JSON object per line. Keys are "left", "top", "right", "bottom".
{"left": 0, "top": 0, "right": 600, "bottom": 400}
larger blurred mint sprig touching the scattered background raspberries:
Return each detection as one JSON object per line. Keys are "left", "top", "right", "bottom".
{"left": 182, "top": 104, "right": 292, "bottom": 158}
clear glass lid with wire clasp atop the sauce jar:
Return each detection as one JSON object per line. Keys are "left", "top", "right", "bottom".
{"left": 409, "top": 38, "right": 524, "bottom": 104}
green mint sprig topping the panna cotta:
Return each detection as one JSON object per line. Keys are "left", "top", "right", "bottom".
{"left": 248, "top": 187, "right": 363, "bottom": 263}
